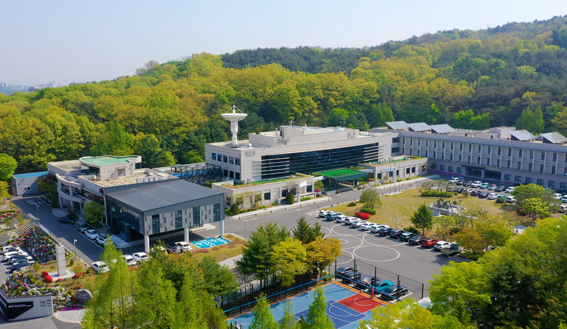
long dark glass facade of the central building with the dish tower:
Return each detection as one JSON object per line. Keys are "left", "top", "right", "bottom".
{"left": 262, "top": 143, "right": 378, "bottom": 179}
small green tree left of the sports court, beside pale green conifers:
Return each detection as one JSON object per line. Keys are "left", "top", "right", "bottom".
{"left": 199, "top": 256, "right": 238, "bottom": 305}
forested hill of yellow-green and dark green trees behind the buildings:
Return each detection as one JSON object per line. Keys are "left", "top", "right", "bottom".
{"left": 0, "top": 17, "right": 567, "bottom": 172}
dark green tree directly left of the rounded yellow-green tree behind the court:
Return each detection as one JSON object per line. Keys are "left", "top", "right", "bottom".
{"left": 236, "top": 223, "right": 289, "bottom": 287}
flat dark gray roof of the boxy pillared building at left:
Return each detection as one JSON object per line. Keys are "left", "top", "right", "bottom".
{"left": 108, "top": 179, "right": 222, "bottom": 211}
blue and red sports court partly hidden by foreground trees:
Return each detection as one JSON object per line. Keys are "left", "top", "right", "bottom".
{"left": 228, "top": 282, "right": 386, "bottom": 329}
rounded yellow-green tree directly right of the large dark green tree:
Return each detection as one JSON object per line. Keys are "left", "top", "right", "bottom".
{"left": 272, "top": 237, "right": 307, "bottom": 287}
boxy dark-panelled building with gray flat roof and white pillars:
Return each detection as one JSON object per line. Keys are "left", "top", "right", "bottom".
{"left": 106, "top": 179, "right": 224, "bottom": 250}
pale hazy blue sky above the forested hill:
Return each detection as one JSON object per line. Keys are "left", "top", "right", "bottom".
{"left": 0, "top": 0, "right": 567, "bottom": 85}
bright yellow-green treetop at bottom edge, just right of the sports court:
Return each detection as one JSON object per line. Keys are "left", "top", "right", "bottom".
{"left": 358, "top": 297, "right": 437, "bottom": 329}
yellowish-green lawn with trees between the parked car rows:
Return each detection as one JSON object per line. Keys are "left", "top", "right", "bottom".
{"left": 324, "top": 189, "right": 516, "bottom": 232}
